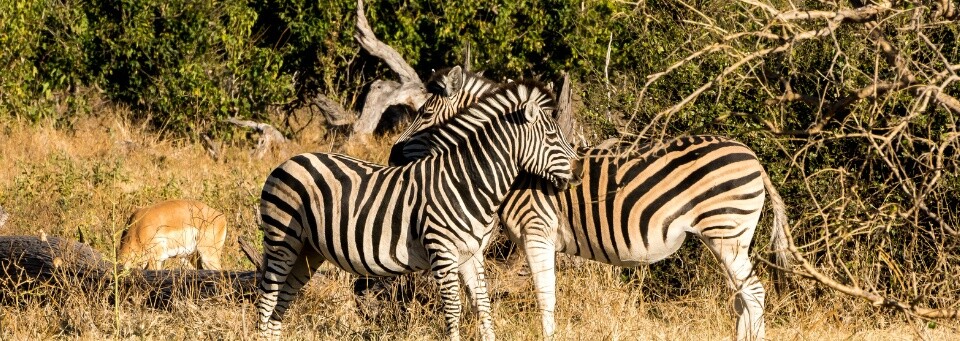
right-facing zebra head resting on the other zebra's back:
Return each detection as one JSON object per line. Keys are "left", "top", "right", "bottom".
{"left": 517, "top": 82, "right": 581, "bottom": 190}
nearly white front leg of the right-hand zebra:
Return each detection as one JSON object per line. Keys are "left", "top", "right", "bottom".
{"left": 523, "top": 228, "right": 557, "bottom": 340}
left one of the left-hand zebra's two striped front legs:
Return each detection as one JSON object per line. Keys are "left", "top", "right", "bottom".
{"left": 431, "top": 253, "right": 462, "bottom": 341}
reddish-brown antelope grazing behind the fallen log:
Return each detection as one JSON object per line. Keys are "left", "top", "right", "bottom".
{"left": 117, "top": 200, "right": 227, "bottom": 270}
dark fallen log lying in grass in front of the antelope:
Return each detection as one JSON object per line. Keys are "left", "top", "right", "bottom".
{"left": 0, "top": 236, "right": 258, "bottom": 306}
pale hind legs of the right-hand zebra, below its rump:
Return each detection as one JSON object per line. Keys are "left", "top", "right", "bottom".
{"left": 703, "top": 233, "right": 766, "bottom": 341}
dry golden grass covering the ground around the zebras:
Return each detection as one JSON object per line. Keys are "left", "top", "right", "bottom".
{"left": 0, "top": 110, "right": 960, "bottom": 340}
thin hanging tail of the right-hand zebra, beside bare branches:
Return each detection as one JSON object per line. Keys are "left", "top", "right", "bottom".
{"left": 761, "top": 166, "right": 793, "bottom": 292}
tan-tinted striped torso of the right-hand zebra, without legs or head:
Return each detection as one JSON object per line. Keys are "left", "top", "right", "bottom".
{"left": 516, "top": 136, "right": 764, "bottom": 266}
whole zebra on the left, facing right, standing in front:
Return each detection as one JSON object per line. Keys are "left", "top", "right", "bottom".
{"left": 257, "top": 82, "right": 578, "bottom": 340}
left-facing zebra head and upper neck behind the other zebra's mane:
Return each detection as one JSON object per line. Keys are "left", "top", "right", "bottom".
{"left": 389, "top": 66, "right": 497, "bottom": 166}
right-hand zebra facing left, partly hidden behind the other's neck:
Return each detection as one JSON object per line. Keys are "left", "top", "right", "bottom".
{"left": 390, "top": 68, "right": 790, "bottom": 340}
